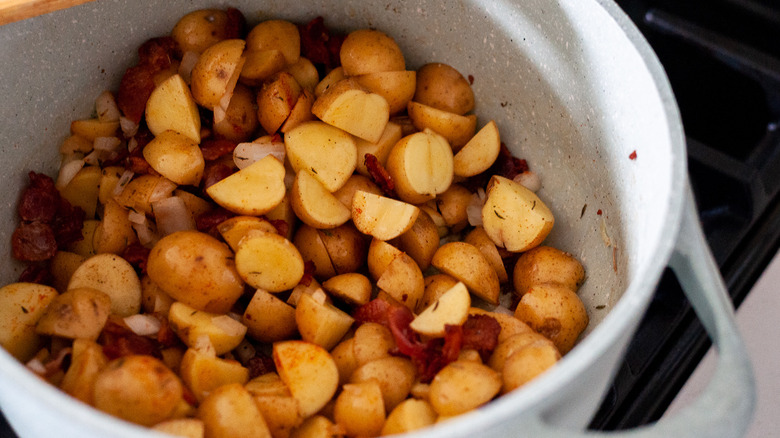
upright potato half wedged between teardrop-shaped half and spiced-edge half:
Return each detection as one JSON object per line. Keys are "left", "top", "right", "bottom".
{"left": 290, "top": 169, "right": 352, "bottom": 228}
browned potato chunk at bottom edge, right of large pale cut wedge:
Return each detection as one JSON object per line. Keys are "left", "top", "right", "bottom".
{"left": 333, "top": 380, "right": 385, "bottom": 436}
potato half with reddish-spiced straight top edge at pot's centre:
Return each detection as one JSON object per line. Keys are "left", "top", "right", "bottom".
{"left": 352, "top": 190, "right": 420, "bottom": 240}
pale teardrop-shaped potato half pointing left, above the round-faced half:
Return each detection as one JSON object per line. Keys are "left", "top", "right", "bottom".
{"left": 206, "top": 155, "right": 286, "bottom": 216}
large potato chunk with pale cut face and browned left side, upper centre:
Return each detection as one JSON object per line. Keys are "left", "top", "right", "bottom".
{"left": 311, "top": 78, "right": 390, "bottom": 143}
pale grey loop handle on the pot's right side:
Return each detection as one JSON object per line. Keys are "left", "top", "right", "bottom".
{"left": 527, "top": 185, "right": 755, "bottom": 438}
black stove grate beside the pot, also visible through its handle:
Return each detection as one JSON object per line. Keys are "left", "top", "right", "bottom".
{"left": 591, "top": 0, "right": 780, "bottom": 430}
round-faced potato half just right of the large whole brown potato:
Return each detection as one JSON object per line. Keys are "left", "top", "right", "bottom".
{"left": 236, "top": 230, "right": 303, "bottom": 292}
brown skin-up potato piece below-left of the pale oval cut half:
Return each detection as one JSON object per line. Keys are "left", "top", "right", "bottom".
{"left": 35, "top": 287, "right": 111, "bottom": 341}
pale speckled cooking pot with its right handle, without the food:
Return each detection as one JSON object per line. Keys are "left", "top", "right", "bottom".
{"left": 0, "top": 0, "right": 754, "bottom": 437}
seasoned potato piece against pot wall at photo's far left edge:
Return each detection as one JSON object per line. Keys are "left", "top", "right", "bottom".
{"left": 0, "top": 283, "right": 57, "bottom": 362}
